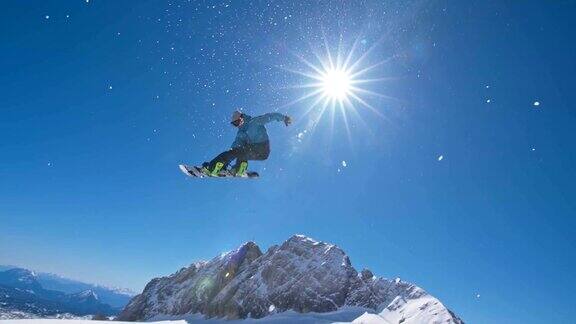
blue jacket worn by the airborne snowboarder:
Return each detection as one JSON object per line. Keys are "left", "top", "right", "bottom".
{"left": 232, "top": 113, "right": 285, "bottom": 148}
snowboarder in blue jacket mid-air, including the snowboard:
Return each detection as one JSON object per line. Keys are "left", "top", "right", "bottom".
{"left": 180, "top": 111, "right": 292, "bottom": 177}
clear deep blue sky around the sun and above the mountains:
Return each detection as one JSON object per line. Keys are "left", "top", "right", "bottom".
{"left": 0, "top": 0, "right": 576, "bottom": 323}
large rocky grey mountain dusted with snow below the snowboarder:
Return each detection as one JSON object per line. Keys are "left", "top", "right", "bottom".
{"left": 118, "top": 235, "right": 462, "bottom": 323}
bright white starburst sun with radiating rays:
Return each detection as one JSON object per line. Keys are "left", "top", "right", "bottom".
{"left": 281, "top": 37, "right": 394, "bottom": 137}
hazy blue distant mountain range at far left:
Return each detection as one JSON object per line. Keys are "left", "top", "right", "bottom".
{"left": 0, "top": 266, "right": 133, "bottom": 317}
